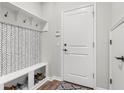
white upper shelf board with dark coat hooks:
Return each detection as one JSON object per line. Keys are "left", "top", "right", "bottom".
{"left": 0, "top": 2, "right": 48, "bottom": 32}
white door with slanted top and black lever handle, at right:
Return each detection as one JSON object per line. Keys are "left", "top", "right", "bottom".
{"left": 110, "top": 24, "right": 124, "bottom": 90}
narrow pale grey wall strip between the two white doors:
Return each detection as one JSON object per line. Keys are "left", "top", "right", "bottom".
{"left": 96, "top": 3, "right": 112, "bottom": 88}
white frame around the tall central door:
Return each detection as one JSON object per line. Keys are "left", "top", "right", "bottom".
{"left": 61, "top": 3, "right": 96, "bottom": 88}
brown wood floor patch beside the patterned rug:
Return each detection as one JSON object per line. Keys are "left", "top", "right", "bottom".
{"left": 37, "top": 80, "right": 60, "bottom": 90}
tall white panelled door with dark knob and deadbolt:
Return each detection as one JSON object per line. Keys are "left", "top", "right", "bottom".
{"left": 63, "top": 7, "right": 94, "bottom": 87}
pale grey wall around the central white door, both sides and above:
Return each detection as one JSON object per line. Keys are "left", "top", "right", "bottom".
{"left": 42, "top": 2, "right": 111, "bottom": 88}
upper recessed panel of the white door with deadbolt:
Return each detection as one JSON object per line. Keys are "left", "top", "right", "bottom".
{"left": 64, "top": 11, "right": 92, "bottom": 46}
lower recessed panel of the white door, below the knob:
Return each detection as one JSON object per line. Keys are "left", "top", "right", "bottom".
{"left": 64, "top": 54, "right": 90, "bottom": 78}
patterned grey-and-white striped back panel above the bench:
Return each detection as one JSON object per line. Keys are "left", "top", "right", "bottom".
{"left": 0, "top": 23, "right": 41, "bottom": 76}
